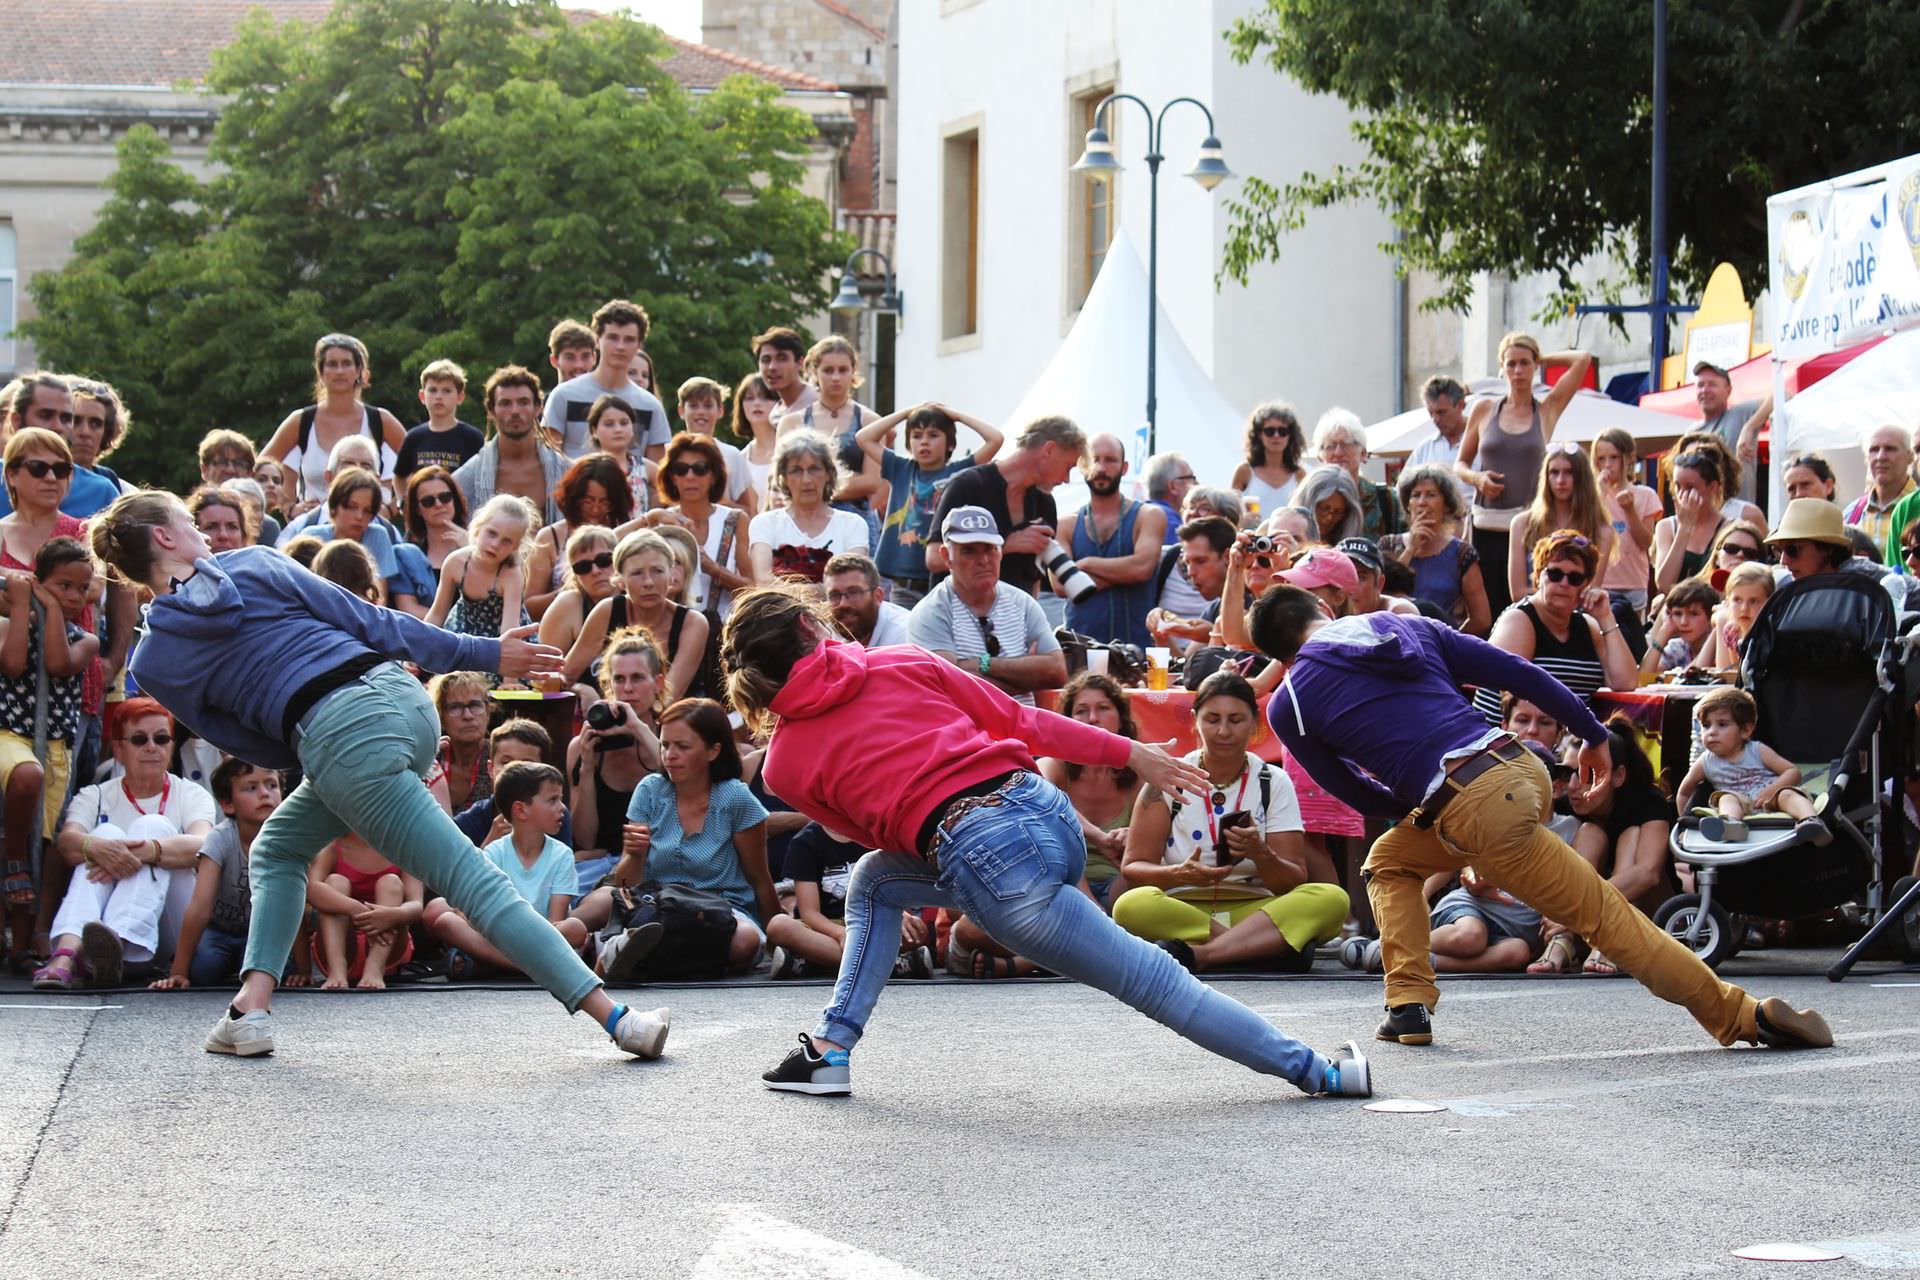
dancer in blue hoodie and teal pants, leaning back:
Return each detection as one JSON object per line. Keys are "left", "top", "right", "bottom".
{"left": 92, "top": 491, "right": 666, "bottom": 1057}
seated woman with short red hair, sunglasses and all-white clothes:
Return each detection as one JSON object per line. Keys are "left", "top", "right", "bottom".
{"left": 35, "top": 699, "right": 219, "bottom": 988}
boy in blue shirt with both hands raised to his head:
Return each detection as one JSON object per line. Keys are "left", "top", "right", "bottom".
{"left": 854, "top": 401, "right": 1004, "bottom": 608}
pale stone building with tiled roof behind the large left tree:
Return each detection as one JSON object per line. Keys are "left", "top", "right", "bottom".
{"left": 0, "top": 0, "right": 856, "bottom": 374}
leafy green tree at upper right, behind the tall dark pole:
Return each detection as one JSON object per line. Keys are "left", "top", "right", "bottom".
{"left": 1223, "top": 0, "right": 1920, "bottom": 307}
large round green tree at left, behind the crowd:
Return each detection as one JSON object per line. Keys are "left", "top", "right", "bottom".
{"left": 25, "top": 0, "right": 847, "bottom": 486}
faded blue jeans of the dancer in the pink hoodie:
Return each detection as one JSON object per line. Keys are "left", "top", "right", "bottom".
{"left": 814, "top": 775, "right": 1327, "bottom": 1094}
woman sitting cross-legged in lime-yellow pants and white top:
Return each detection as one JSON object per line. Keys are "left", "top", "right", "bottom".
{"left": 1114, "top": 672, "right": 1348, "bottom": 971}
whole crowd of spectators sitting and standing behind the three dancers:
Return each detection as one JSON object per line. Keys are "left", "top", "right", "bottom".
{"left": 0, "top": 310, "right": 1920, "bottom": 988}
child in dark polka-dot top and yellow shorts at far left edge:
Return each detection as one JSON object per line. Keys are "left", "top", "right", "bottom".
{"left": 0, "top": 537, "right": 100, "bottom": 952}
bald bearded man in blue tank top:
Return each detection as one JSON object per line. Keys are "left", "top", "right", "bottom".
{"left": 1062, "top": 434, "right": 1167, "bottom": 647}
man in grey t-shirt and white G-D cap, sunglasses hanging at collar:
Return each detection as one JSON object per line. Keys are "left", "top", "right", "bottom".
{"left": 906, "top": 507, "right": 1068, "bottom": 706}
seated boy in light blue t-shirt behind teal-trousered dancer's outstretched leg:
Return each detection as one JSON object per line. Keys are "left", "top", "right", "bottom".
{"left": 426, "top": 760, "right": 589, "bottom": 981}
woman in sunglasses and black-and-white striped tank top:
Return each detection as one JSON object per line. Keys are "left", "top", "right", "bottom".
{"left": 1473, "top": 530, "right": 1640, "bottom": 725}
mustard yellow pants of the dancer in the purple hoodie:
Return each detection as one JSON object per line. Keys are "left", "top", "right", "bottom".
{"left": 1367, "top": 754, "right": 1757, "bottom": 1044}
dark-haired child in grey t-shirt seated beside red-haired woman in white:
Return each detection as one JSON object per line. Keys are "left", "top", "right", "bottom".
{"left": 154, "top": 758, "right": 307, "bottom": 990}
